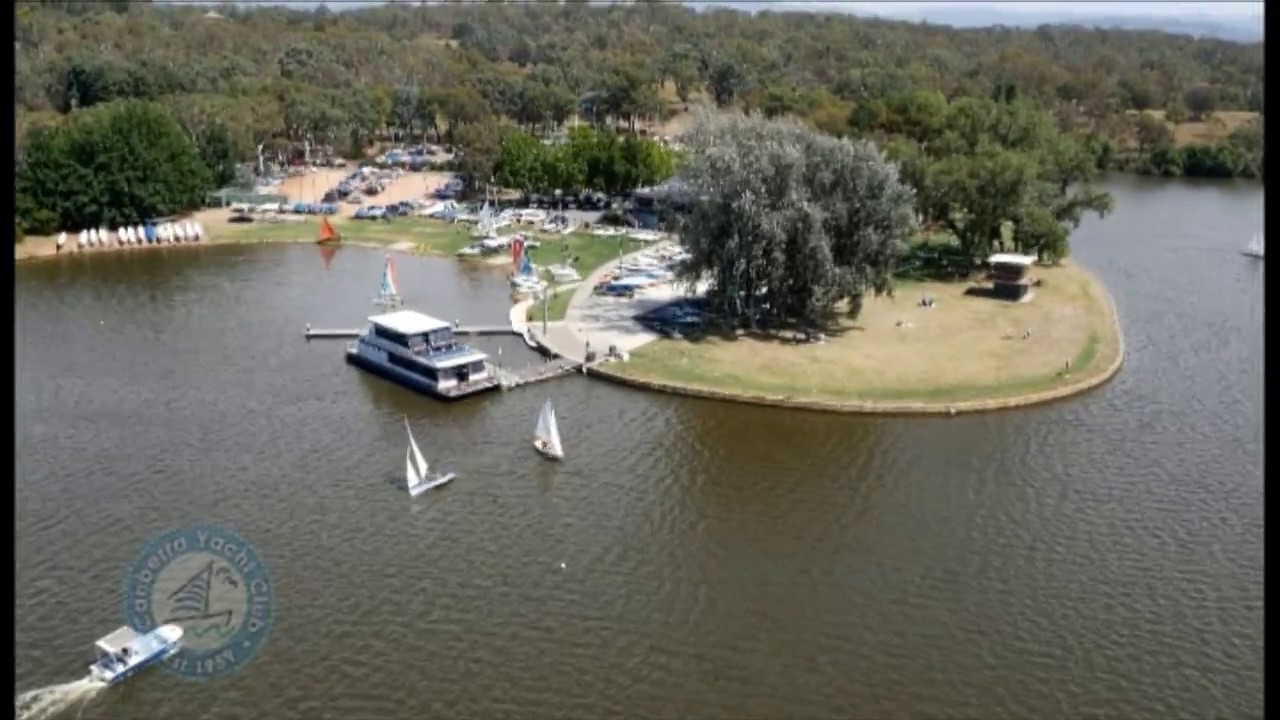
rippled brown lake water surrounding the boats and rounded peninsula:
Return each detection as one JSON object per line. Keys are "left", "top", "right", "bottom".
{"left": 15, "top": 178, "right": 1263, "bottom": 720}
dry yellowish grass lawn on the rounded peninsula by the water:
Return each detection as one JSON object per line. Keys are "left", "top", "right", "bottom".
{"left": 609, "top": 260, "right": 1121, "bottom": 406}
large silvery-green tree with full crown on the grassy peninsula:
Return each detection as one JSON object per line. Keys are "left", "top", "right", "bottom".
{"left": 678, "top": 114, "right": 916, "bottom": 327}
